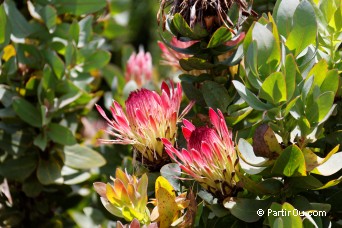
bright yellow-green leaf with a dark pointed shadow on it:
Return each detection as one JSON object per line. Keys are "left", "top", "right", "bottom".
{"left": 259, "top": 72, "right": 286, "bottom": 104}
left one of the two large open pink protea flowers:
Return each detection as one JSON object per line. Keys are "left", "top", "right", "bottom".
{"left": 96, "top": 82, "right": 193, "bottom": 170}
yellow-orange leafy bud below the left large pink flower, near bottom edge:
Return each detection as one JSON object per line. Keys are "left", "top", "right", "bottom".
{"left": 94, "top": 168, "right": 150, "bottom": 224}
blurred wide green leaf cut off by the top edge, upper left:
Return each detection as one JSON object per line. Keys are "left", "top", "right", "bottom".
{"left": 54, "top": 0, "right": 107, "bottom": 16}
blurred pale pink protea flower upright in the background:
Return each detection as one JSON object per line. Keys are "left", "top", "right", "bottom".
{"left": 125, "top": 48, "right": 152, "bottom": 88}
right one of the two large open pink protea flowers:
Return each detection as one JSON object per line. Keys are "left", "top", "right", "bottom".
{"left": 162, "top": 108, "right": 238, "bottom": 199}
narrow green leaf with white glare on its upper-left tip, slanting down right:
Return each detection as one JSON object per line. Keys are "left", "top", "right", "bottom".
{"left": 232, "top": 80, "right": 270, "bottom": 111}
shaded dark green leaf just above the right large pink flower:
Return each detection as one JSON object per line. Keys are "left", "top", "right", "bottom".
{"left": 201, "top": 81, "right": 232, "bottom": 112}
